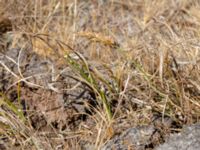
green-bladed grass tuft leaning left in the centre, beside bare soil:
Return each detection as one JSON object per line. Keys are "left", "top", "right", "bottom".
{"left": 65, "top": 52, "right": 117, "bottom": 121}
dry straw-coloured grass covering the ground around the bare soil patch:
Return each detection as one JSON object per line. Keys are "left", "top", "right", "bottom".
{"left": 0, "top": 0, "right": 200, "bottom": 149}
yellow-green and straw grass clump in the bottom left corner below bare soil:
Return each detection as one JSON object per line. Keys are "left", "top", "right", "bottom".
{"left": 0, "top": 93, "right": 30, "bottom": 148}
